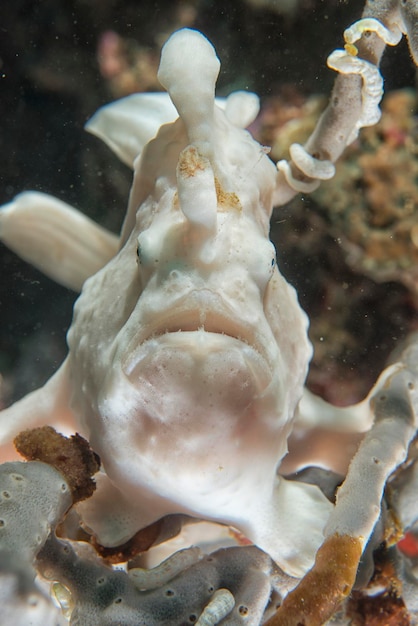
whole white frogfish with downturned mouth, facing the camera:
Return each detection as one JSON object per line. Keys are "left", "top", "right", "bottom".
{"left": 0, "top": 29, "right": 332, "bottom": 576}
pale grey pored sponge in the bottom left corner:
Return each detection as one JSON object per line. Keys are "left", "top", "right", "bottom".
{"left": 0, "top": 461, "right": 72, "bottom": 626}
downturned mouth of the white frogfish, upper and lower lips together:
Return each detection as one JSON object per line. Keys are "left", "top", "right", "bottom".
{"left": 122, "top": 301, "right": 275, "bottom": 393}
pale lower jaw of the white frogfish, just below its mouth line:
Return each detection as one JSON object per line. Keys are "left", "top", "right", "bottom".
{"left": 122, "top": 328, "right": 274, "bottom": 410}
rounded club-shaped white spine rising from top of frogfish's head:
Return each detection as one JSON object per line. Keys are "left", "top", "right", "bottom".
{"left": 158, "top": 28, "right": 220, "bottom": 158}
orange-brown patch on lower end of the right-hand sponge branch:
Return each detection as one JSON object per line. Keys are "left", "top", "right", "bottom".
{"left": 265, "top": 535, "right": 362, "bottom": 626}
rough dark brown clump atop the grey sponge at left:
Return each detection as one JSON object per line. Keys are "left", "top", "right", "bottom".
{"left": 14, "top": 426, "right": 100, "bottom": 504}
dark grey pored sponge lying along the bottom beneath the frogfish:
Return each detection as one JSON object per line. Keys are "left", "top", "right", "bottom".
{"left": 38, "top": 535, "right": 297, "bottom": 626}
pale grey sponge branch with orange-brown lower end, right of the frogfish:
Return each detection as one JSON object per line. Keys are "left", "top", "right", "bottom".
{"left": 266, "top": 351, "right": 418, "bottom": 626}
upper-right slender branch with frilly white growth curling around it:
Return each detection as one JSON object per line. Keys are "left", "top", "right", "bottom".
{"left": 274, "top": 11, "right": 418, "bottom": 205}
